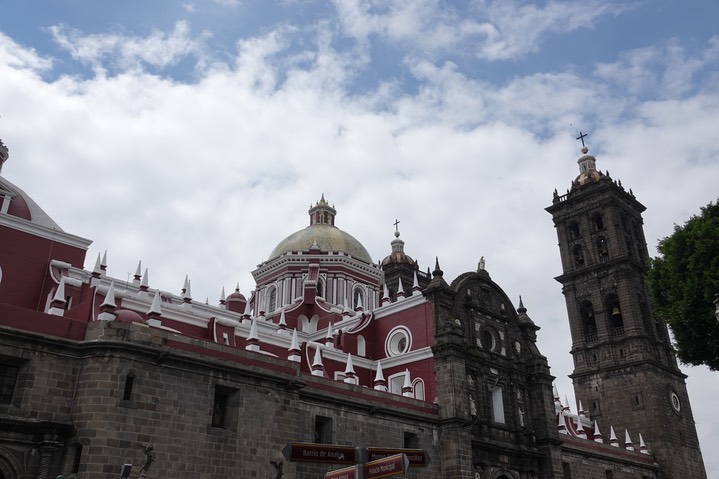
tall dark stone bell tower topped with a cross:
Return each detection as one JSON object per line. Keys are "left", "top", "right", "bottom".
{"left": 546, "top": 142, "right": 706, "bottom": 478}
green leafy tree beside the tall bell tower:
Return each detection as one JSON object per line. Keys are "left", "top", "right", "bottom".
{"left": 647, "top": 202, "right": 719, "bottom": 371}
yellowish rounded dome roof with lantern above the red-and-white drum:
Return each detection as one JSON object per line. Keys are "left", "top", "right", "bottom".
{"left": 268, "top": 195, "right": 372, "bottom": 263}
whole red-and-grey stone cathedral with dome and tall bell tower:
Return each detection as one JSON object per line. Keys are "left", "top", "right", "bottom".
{"left": 0, "top": 136, "right": 706, "bottom": 479}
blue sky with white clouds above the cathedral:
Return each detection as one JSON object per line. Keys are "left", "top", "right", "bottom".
{"left": 0, "top": 0, "right": 719, "bottom": 477}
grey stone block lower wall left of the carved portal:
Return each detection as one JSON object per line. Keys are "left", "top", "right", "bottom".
{"left": 0, "top": 322, "right": 438, "bottom": 479}
